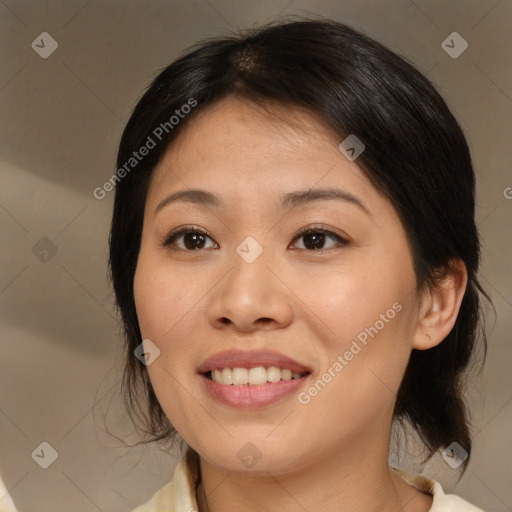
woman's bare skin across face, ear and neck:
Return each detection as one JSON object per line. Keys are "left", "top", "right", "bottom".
{"left": 134, "top": 98, "right": 467, "bottom": 512}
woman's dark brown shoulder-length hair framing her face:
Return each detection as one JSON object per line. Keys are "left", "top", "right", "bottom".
{"left": 110, "top": 19, "right": 488, "bottom": 467}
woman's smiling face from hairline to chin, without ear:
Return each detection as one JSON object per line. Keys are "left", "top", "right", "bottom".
{"left": 134, "top": 99, "right": 418, "bottom": 474}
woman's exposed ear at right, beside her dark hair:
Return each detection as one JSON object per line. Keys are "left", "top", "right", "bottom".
{"left": 412, "top": 259, "right": 468, "bottom": 350}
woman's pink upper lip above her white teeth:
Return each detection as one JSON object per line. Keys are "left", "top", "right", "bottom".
{"left": 197, "top": 350, "right": 310, "bottom": 373}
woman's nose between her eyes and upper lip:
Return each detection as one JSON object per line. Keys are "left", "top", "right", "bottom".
{"left": 208, "top": 243, "right": 293, "bottom": 333}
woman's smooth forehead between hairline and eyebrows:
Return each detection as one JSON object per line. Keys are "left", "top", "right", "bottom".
{"left": 148, "top": 98, "right": 384, "bottom": 213}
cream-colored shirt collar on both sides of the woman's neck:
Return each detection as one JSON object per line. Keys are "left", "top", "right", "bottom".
{"left": 133, "top": 456, "right": 483, "bottom": 512}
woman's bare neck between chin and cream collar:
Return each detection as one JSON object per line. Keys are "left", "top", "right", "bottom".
{"left": 197, "top": 420, "right": 432, "bottom": 512}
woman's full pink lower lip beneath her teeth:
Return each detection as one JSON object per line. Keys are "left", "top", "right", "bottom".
{"left": 200, "top": 374, "right": 310, "bottom": 409}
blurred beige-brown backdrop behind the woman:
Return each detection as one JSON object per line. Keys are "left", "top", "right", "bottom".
{"left": 0, "top": 0, "right": 512, "bottom": 512}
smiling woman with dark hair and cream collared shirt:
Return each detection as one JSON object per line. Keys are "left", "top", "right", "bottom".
{"left": 110, "top": 20, "right": 487, "bottom": 512}
